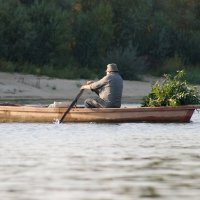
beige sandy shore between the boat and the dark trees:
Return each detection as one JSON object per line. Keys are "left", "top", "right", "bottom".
{"left": 0, "top": 72, "right": 198, "bottom": 103}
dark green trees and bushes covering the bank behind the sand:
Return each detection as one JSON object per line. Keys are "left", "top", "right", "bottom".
{"left": 0, "top": 0, "right": 200, "bottom": 83}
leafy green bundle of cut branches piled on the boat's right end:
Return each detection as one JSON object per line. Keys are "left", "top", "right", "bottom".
{"left": 143, "top": 71, "right": 200, "bottom": 107}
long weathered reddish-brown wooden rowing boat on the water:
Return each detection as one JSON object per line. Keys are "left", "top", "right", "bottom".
{"left": 0, "top": 105, "right": 200, "bottom": 123}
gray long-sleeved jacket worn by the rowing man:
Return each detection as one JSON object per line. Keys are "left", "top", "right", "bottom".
{"left": 90, "top": 72, "right": 123, "bottom": 108}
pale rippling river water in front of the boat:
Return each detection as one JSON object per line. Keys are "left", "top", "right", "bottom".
{"left": 0, "top": 112, "right": 200, "bottom": 200}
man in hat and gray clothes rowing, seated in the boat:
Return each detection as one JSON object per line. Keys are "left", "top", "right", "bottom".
{"left": 81, "top": 63, "right": 123, "bottom": 108}
